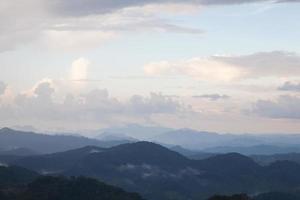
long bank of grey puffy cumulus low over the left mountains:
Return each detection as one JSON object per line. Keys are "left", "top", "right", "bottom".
{"left": 0, "top": 88, "right": 186, "bottom": 124}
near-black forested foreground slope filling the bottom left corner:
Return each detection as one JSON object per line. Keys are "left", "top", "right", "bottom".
{"left": 0, "top": 167, "right": 143, "bottom": 200}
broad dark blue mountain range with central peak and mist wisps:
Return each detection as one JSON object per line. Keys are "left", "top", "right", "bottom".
{"left": 10, "top": 142, "right": 300, "bottom": 200}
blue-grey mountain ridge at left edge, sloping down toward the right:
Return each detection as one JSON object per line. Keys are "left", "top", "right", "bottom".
{"left": 0, "top": 128, "right": 127, "bottom": 153}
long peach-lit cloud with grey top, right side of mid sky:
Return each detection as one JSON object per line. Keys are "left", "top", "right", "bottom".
{"left": 144, "top": 51, "right": 300, "bottom": 82}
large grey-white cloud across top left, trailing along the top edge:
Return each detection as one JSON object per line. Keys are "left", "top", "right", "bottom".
{"left": 0, "top": 0, "right": 299, "bottom": 51}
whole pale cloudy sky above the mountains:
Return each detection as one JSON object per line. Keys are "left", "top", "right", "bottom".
{"left": 0, "top": 0, "right": 300, "bottom": 133}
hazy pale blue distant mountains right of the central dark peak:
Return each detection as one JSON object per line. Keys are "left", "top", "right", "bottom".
{"left": 151, "top": 129, "right": 300, "bottom": 152}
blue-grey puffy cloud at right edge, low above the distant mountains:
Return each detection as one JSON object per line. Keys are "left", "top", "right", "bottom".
{"left": 252, "top": 95, "right": 300, "bottom": 119}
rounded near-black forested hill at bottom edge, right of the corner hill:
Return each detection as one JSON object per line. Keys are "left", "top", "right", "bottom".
{"left": 20, "top": 177, "right": 142, "bottom": 200}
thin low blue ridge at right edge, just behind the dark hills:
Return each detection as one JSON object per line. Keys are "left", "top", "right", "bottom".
{"left": 203, "top": 145, "right": 300, "bottom": 155}
